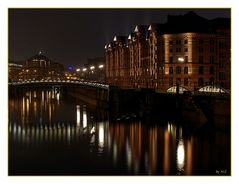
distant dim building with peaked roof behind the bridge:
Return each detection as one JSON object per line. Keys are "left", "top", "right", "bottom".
{"left": 19, "top": 52, "right": 64, "bottom": 80}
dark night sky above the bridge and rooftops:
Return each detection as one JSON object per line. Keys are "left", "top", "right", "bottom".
{"left": 9, "top": 9, "right": 230, "bottom": 66}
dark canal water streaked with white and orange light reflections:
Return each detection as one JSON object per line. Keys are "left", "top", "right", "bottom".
{"left": 9, "top": 90, "right": 231, "bottom": 176}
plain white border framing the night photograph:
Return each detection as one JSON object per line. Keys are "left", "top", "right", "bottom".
{"left": 0, "top": 0, "right": 239, "bottom": 184}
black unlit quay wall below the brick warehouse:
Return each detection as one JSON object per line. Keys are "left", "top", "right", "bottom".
{"left": 109, "top": 87, "right": 230, "bottom": 128}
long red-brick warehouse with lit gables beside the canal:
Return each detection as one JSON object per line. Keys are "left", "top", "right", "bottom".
{"left": 105, "top": 12, "right": 231, "bottom": 91}
